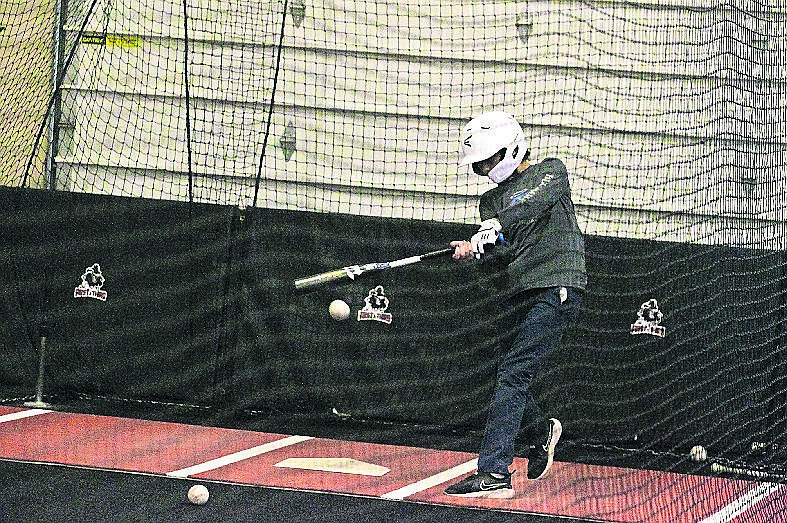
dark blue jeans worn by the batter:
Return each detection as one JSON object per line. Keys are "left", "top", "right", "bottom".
{"left": 478, "top": 287, "right": 583, "bottom": 473}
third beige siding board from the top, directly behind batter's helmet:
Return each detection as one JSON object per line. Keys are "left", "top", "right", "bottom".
{"left": 60, "top": 90, "right": 785, "bottom": 218}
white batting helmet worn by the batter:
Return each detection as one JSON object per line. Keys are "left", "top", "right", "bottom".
{"left": 459, "top": 111, "right": 528, "bottom": 183}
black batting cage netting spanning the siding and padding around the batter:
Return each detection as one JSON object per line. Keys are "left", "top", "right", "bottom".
{"left": 0, "top": 0, "right": 787, "bottom": 494}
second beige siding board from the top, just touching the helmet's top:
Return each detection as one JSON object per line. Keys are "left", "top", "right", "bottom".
{"left": 65, "top": 42, "right": 787, "bottom": 142}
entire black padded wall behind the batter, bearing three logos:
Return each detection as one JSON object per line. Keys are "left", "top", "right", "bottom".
{"left": 0, "top": 188, "right": 787, "bottom": 453}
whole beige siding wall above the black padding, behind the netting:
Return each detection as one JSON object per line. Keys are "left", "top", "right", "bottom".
{"left": 50, "top": 0, "right": 787, "bottom": 246}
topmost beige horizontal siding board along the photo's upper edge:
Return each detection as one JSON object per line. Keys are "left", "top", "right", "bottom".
{"left": 69, "top": 0, "right": 787, "bottom": 80}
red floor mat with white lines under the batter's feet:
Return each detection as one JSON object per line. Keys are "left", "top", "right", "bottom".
{"left": 0, "top": 406, "right": 787, "bottom": 523}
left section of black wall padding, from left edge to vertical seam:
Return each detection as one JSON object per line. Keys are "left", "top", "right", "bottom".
{"left": 0, "top": 190, "right": 240, "bottom": 402}
